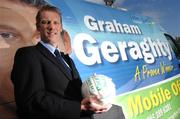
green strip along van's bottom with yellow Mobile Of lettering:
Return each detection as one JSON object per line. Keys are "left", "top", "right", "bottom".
{"left": 114, "top": 76, "right": 180, "bottom": 119}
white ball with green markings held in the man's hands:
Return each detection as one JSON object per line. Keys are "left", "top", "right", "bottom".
{"left": 82, "top": 74, "right": 116, "bottom": 109}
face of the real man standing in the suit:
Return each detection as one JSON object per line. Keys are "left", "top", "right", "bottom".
{"left": 38, "top": 11, "right": 62, "bottom": 46}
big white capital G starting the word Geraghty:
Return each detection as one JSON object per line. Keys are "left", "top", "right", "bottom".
{"left": 73, "top": 33, "right": 102, "bottom": 65}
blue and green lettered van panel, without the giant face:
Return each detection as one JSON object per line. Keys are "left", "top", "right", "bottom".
{"left": 49, "top": 0, "right": 180, "bottom": 119}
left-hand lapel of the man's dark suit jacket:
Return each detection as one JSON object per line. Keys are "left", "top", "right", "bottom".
{"left": 36, "top": 43, "right": 72, "bottom": 80}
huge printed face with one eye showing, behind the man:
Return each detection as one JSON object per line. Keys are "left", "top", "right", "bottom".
{"left": 0, "top": 0, "right": 38, "bottom": 103}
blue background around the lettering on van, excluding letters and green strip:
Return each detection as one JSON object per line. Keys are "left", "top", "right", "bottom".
{"left": 49, "top": 0, "right": 180, "bottom": 95}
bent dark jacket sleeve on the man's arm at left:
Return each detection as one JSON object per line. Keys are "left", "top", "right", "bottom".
{"left": 11, "top": 49, "right": 80, "bottom": 119}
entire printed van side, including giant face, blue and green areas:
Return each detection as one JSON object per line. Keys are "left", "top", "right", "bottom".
{"left": 0, "top": 0, "right": 180, "bottom": 119}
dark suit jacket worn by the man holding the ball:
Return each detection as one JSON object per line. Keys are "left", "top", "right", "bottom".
{"left": 11, "top": 43, "right": 82, "bottom": 119}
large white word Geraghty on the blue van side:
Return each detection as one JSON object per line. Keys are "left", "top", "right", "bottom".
{"left": 73, "top": 33, "right": 172, "bottom": 65}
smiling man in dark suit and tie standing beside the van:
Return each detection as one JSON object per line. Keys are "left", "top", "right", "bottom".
{"left": 11, "top": 6, "right": 108, "bottom": 119}
